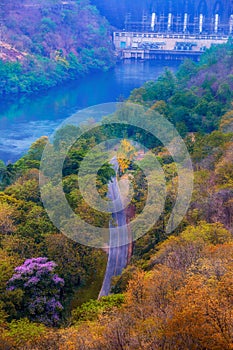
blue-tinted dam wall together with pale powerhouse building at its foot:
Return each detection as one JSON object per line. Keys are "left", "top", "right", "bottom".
{"left": 91, "top": 0, "right": 233, "bottom": 59}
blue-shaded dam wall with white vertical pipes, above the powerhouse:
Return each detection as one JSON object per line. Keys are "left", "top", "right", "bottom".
{"left": 91, "top": 0, "right": 233, "bottom": 35}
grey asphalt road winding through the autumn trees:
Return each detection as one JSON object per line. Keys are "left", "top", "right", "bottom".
{"left": 99, "top": 157, "right": 129, "bottom": 298}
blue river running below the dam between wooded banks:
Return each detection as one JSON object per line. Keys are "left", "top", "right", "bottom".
{"left": 0, "top": 61, "right": 180, "bottom": 163}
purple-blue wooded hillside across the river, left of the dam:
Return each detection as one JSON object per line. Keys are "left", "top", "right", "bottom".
{"left": 0, "top": 0, "right": 114, "bottom": 96}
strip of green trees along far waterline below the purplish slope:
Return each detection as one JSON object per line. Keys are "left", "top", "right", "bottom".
{"left": 0, "top": 52, "right": 115, "bottom": 102}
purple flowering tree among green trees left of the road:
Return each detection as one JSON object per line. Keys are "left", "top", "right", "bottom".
{"left": 7, "top": 257, "right": 64, "bottom": 326}
